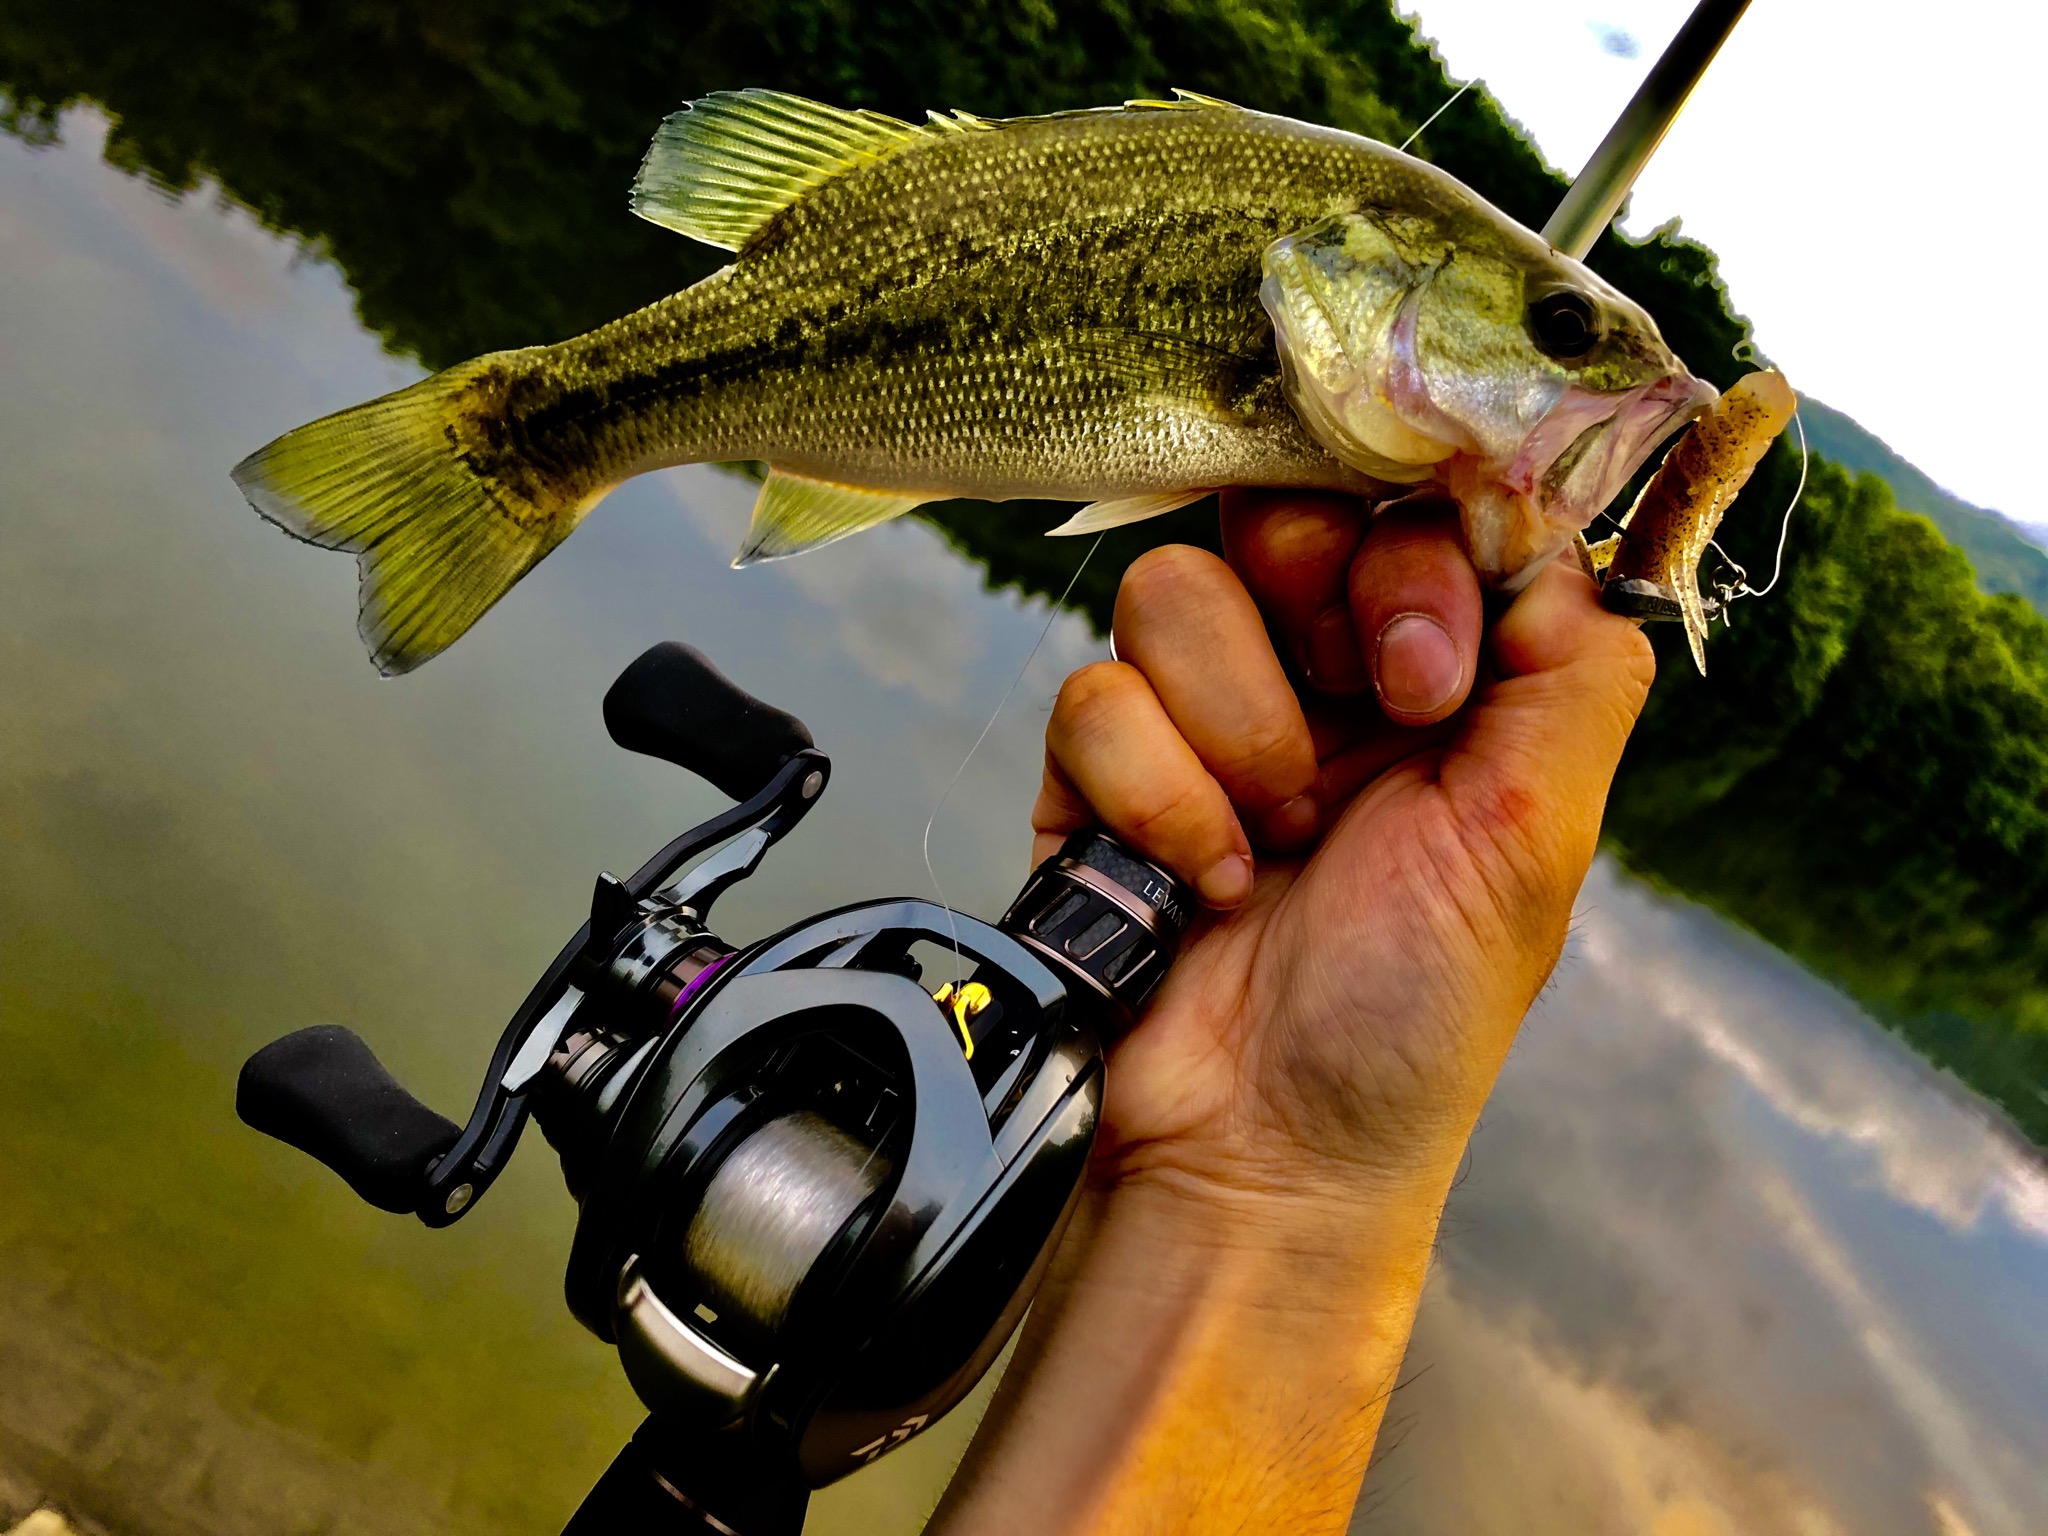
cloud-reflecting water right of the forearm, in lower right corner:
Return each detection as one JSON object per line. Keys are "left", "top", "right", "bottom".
{"left": 1374, "top": 864, "right": 2048, "bottom": 1534}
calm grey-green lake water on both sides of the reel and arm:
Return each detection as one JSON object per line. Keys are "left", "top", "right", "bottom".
{"left": 0, "top": 113, "right": 2048, "bottom": 1536}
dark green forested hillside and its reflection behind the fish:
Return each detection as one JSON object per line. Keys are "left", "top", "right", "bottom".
{"left": 0, "top": 0, "right": 2048, "bottom": 1143}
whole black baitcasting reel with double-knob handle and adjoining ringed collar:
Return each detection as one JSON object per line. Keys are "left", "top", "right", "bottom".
{"left": 236, "top": 645, "right": 1194, "bottom": 1536}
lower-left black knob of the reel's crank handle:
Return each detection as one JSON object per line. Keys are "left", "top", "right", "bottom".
{"left": 236, "top": 1024, "right": 461, "bottom": 1214}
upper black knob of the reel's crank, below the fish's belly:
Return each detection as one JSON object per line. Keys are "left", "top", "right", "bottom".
{"left": 604, "top": 641, "right": 811, "bottom": 801}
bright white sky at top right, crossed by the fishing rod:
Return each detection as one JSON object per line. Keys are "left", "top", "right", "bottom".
{"left": 1405, "top": 0, "right": 2048, "bottom": 526}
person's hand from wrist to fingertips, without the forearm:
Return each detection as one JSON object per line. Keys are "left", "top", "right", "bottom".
{"left": 1032, "top": 492, "right": 1655, "bottom": 1198}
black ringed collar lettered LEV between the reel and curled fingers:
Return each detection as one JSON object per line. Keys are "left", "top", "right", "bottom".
{"left": 1001, "top": 831, "right": 1194, "bottom": 1024}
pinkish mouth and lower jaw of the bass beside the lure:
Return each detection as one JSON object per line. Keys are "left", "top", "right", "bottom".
{"left": 1440, "top": 369, "right": 1716, "bottom": 592}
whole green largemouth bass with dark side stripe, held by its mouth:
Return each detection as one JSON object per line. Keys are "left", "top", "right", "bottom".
{"left": 236, "top": 90, "right": 1714, "bottom": 674}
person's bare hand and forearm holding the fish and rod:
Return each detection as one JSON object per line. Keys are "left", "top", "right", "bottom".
{"left": 928, "top": 494, "right": 1653, "bottom": 1536}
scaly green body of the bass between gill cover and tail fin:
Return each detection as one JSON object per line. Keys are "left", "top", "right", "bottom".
{"left": 522, "top": 111, "right": 1378, "bottom": 498}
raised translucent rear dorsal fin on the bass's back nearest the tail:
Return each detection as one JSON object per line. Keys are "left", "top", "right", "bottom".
{"left": 633, "top": 90, "right": 933, "bottom": 250}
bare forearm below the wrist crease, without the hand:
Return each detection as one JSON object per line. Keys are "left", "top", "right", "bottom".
{"left": 930, "top": 1165, "right": 1450, "bottom": 1536}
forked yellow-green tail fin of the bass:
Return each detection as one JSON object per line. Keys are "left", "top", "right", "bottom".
{"left": 233, "top": 352, "right": 608, "bottom": 678}
